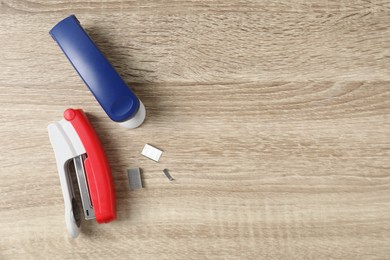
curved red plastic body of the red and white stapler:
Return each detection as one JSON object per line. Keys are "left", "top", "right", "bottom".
{"left": 64, "top": 109, "right": 116, "bottom": 223}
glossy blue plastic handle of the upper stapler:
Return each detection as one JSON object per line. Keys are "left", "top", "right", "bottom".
{"left": 50, "top": 15, "right": 140, "bottom": 122}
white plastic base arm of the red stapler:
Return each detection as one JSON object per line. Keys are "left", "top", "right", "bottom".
{"left": 48, "top": 119, "right": 85, "bottom": 238}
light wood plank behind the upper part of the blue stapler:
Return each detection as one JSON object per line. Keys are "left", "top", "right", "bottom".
{"left": 0, "top": 8, "right": 390, "bottom": 85}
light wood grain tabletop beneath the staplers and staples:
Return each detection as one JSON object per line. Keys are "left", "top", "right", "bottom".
{"left": 0, "top": 0, "right": 390, "bottom": 259}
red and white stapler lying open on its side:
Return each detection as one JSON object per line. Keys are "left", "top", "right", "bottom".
{"left": 48, "top": 109, "right": 116, "bottom": 238}
